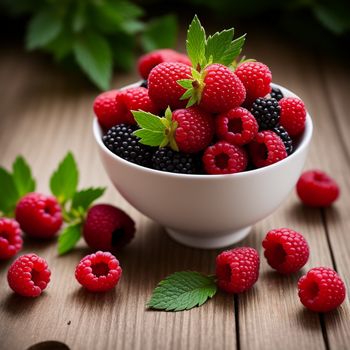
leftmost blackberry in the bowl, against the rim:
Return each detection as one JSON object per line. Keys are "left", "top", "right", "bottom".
{"left": 102, "top": 124, "right": 153, "bottom": 167}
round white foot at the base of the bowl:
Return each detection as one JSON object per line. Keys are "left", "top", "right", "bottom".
{"left": 166, "top": 226, "right": 252, "bottom": 249}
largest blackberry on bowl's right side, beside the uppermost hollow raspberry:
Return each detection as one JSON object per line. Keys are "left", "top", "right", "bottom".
{"left": 250, "top": 98, "right": 281, "bottom": 130}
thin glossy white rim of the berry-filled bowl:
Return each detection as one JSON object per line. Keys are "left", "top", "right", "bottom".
{"left": 92, "top": 81, "right": 313, "bottom": 181}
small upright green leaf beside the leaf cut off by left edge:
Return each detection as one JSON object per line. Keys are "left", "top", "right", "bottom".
{"left": 12, "top": 156, "right": 35, "bottom": 197}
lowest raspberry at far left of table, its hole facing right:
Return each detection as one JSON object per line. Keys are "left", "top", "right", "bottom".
{"left": 7, "top": 254, "right": 51, "bottom": 297}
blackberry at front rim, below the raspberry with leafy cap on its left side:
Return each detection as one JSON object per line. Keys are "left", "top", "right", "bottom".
{"left": 152, "top": 148, "right": 196, "bottom": 174}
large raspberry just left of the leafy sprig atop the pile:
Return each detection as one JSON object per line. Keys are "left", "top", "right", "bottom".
{"left": 148, "top": 62, "right": 191, "bottom": 109}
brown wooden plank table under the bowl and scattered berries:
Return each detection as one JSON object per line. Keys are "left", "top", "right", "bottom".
{"left": 0, "top": 33, "right": 350, "bottom": 350}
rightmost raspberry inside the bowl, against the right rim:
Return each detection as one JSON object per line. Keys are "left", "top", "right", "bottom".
{"left": 278, "top": 97, "right": 306, "bottom": 137}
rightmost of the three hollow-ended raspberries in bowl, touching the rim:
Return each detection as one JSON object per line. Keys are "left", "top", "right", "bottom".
{"left": 249, "top": 130, "right": 287, "bottom": 168}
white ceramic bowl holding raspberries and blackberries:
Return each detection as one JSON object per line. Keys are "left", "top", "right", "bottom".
{"left": 93, "top": 85, "right": 312, "bottom": 248}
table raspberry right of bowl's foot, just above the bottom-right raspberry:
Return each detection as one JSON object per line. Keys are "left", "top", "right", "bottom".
{"left": 262, "top": 228, "right": 309, "bottom": 274}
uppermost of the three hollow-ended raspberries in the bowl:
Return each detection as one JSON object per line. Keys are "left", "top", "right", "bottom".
{"left": 215, "top": 107, "right": 259, "bottom": 146}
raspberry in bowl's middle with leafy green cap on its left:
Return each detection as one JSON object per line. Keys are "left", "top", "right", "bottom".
{"left": 172, "top": 107, "right": 214, "bottom": 153}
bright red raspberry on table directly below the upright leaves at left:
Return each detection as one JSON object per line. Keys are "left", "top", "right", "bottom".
{"left": 16, "top": 193, "right": 63, "bottom": 238}
